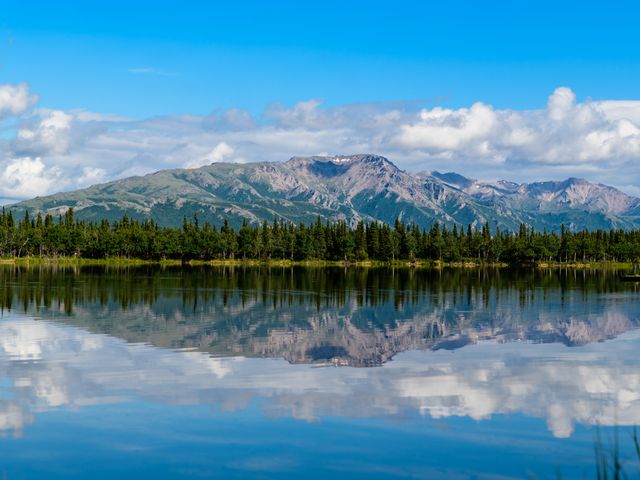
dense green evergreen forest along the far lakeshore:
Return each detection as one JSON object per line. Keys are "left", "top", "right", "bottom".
{"left": 0, "top": 209, "right": 640, "bottom": 264}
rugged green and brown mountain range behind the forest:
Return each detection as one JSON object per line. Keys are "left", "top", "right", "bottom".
{"left": 10, "top": 154, "right": 640, "bottom": 231}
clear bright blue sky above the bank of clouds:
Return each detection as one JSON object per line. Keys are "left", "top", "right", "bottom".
{"left": 5, "top": 0, "right": 640, "bottom": 117}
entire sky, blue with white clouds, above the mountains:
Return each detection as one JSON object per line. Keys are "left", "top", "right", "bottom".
{"left": 0, "top": 0, "right": 640, "bottom": 202}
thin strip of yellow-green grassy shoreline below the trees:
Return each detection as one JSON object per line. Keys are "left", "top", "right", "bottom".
{"left": 0, "top": 257, "right": 633, "bottom": 270}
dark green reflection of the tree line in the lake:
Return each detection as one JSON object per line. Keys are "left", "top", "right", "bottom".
{"left": 0, "top": 265, "right": 627, "bottom": 316}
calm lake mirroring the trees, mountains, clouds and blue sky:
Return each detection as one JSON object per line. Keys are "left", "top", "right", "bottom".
{"left": 0, "top": 267, "right": 640, "bottom": 479}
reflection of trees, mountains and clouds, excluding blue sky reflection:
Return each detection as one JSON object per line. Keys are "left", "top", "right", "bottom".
{"left": 0, "top": 267, "right": 640, "bottom": 437}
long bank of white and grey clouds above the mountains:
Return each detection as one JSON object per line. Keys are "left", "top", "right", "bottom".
{"left": 0, "top": 85, "right": 640, "bottom": 198}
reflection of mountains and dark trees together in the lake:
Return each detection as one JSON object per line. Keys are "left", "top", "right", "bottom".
{"left": 0, "top": 268, "right": 640, "bottom": 367}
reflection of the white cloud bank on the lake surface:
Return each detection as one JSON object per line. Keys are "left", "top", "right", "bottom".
{"left": 0, "top": 316, "right": 640, "bottom": 437}
